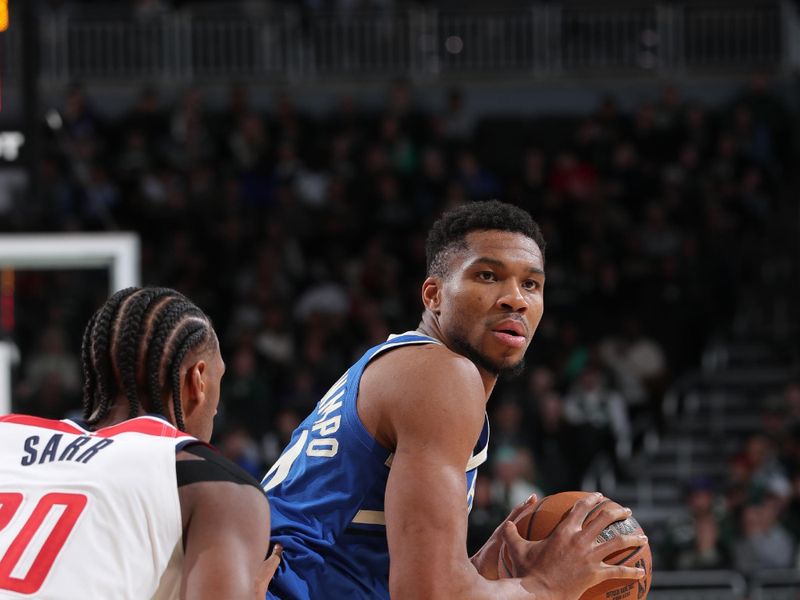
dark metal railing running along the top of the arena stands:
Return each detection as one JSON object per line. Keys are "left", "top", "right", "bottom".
{"left": 2, "top": 0, "right": 800, "bottom": 84}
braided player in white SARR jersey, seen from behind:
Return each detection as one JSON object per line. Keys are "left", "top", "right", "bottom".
{"left": 0, "top": 288, "right": 269, "bottom": 600}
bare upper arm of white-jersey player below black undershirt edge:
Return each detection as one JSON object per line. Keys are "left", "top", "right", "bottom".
{"left": 179, "top": 450, "right": 270, "bottom": 600}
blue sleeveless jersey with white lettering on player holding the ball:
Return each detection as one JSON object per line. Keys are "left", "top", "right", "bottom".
{"left": 261, "top": 332, "right": 489, "bottom": 600}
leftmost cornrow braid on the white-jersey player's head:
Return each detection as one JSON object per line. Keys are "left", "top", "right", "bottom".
{"left": 83, "top": 287, "right": 139, "bottom": 425}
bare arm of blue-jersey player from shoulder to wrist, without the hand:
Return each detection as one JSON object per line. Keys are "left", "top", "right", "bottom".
{"left": 368, "top": 348, "right": 536, "bottom": 600}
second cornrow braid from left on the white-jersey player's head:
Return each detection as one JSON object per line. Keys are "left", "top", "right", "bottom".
{"left": 114, "top": 288, "right": 175, "bottom": 418}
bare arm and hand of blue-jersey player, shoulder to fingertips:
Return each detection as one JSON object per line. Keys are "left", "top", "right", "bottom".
{"left": 358, "top": 347, "right": 644, "bottom": 600}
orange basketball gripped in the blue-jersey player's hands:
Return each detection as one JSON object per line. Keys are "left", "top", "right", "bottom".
{"left": 498, "top": 492, "right": 653, "bottom": 600}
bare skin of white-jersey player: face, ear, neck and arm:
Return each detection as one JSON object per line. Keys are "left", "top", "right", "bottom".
{"left": 98, "top": 344, "right": 280, "bottom": 600}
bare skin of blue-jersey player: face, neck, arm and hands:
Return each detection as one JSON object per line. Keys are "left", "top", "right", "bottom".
{"left": 358, "top": 230, "right": 646, "bottom": 600}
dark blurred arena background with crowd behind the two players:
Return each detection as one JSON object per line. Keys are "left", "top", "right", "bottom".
{"left": 0, "top": 0, "right": 800, "bottom": 600}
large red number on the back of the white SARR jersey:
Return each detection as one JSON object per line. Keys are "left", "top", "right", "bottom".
{"left": 0, "top": 492, "right": 86, "bottom": 594}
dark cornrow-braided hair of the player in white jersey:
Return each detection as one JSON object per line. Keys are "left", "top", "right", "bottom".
{"left": 81, "top": 287, "right": 217, "bottom": 430}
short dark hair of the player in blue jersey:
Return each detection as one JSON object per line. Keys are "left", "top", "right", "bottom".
{"left": 425, "top": 200, "right": 545, "bottom": 277}
